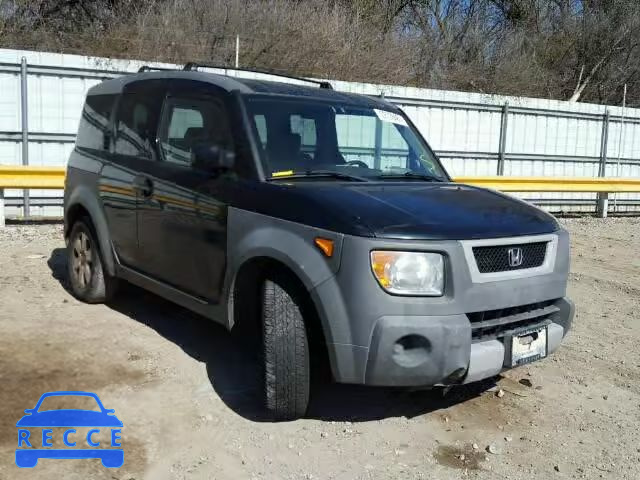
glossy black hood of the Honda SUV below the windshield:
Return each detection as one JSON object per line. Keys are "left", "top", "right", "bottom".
{"left": 289, "top": 182, "right": 559, "bottom": 240}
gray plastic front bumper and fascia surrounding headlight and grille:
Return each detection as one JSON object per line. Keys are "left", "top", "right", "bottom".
{"left": 311, "top": 230, "right": 574, "bottom": 386}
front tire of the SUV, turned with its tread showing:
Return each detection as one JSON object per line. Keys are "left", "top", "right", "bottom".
{"left": 262, "top": 279, "right": 311, "bottom": 420}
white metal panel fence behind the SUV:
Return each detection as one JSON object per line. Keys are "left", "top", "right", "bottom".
{"left": 0, "top": 49, "right": 640, "bottom": 216}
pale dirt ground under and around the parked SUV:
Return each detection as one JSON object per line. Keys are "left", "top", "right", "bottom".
{"left": 0, "top": 218, "right": 640, "bottom": 480}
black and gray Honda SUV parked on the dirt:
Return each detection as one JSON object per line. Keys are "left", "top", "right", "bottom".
{"left": 64, "top": 64, "right": 574, "bottom": 419}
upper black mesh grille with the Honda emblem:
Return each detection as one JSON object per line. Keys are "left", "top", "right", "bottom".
{"left": 473, "top": 242, "right": 549, "bottom": 273}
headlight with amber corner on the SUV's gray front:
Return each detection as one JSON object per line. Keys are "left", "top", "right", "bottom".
{"left": 371, "top": 250, "right": 444, "bottom": 297}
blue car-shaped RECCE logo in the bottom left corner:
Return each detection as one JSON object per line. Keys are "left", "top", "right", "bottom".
{"left": 16, "top": 392, "right": 124, "bottom": 468}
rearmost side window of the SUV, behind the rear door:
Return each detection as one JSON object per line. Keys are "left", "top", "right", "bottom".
{"left": 76, "top": 95, "right": 116, "bottom": 150}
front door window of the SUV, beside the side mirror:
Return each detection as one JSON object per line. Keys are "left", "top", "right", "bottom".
{"left": 158, "top": 97, "right": 233, "bottom": 165}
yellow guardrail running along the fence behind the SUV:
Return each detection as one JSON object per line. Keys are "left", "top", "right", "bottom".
{"left": 0, "top": 166, "right": 640, "bottom": 193}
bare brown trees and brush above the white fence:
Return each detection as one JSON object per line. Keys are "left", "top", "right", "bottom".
{"left": 0, "top": 0, "right": 640, "bottom": 105}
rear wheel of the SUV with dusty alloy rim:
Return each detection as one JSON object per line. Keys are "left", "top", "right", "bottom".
{"left": 67, "top": 218, "right": 117, "bottom": 303}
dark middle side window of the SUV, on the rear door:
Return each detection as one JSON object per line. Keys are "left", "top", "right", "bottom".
{"left": 116, "top": 91, "right": 161, "bottom": 159}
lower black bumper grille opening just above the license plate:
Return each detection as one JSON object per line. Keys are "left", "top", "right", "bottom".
{"left": 467, "top": 300, "right": 560, "bottom": 340}
